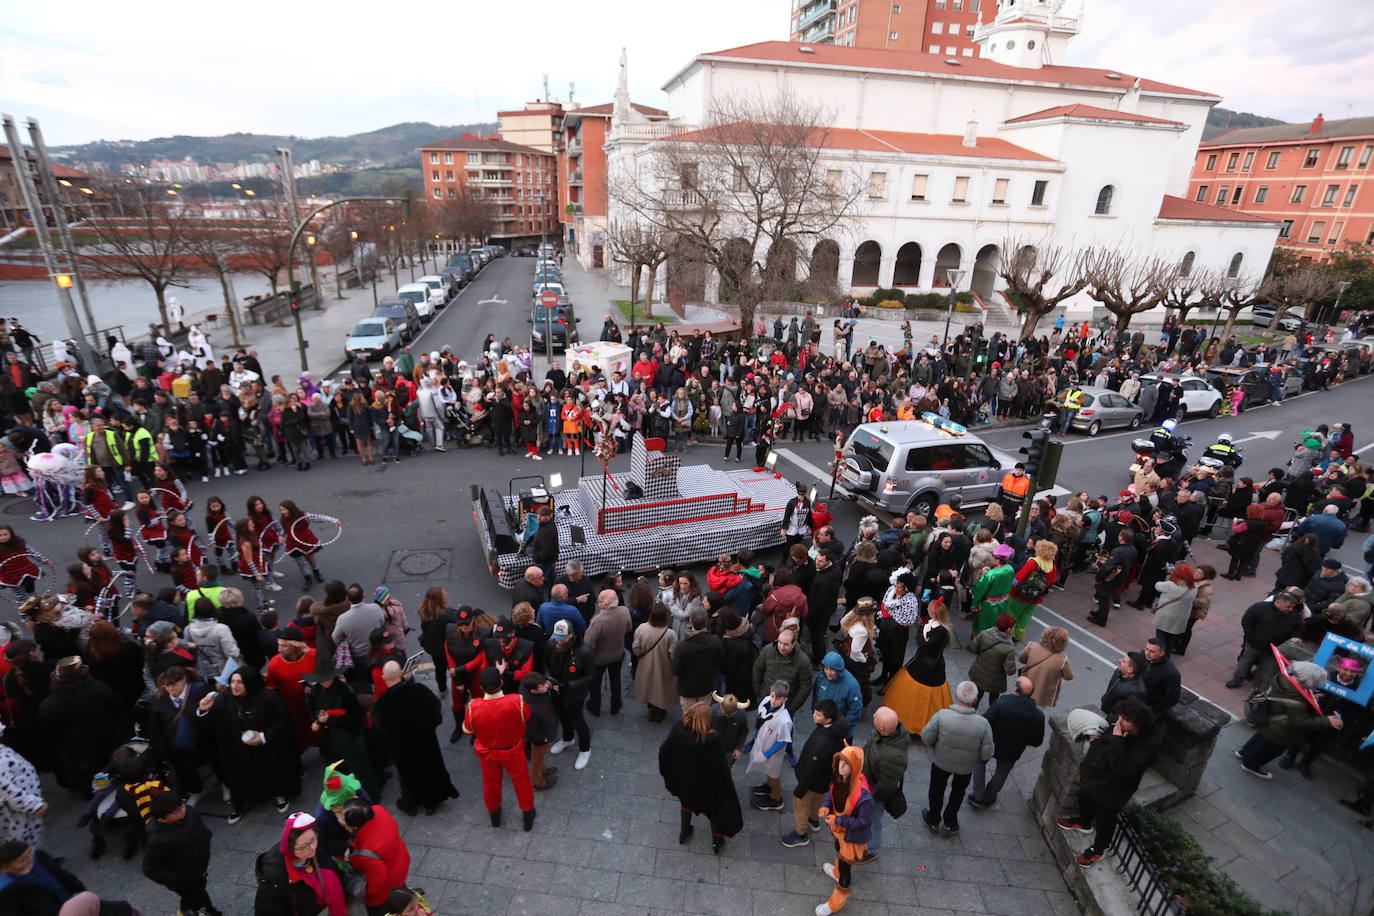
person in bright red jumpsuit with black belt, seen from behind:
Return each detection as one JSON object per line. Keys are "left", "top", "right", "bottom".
{"left": 463, "top": 661, "right": 534, "bottom": 831}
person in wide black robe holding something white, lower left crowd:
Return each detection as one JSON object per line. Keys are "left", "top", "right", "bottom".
{"left": 195, "top": 667, "right": 301, "bottom": 824}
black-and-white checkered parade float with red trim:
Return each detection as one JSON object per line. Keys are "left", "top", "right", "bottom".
{"left": 478, "top": 435, "right": 797, "bottom": 588}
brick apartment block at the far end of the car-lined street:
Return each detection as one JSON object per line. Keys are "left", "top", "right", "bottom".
{"left": 419, "top": 135, "right": 559, "bottom": 246}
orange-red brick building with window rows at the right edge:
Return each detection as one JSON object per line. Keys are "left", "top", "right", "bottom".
{"left": 1189, "top": 115, "right": 1374, "bottom": 261}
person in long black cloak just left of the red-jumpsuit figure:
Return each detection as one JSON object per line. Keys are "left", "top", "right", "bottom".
{"left": 372, "top": 661, "right": 458, "bottom": 817}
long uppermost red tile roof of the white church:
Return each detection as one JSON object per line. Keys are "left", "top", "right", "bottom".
{"left": 698, "top": 41, "right": 1220, "bottom": 99}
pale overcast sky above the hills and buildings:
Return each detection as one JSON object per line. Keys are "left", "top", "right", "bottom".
{"left": 0, "top": 0, "right": 1374, "bottom": 144}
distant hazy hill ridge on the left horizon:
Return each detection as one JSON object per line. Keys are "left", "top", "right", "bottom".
{"left": 52, "top": 121, "right": 497, "bottom": 169}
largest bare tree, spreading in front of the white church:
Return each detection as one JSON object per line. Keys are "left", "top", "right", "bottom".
{"left": 609, "top": 92, "right": 864, "bottom": 330}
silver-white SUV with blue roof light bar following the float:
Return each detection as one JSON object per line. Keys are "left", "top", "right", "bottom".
{"left": 837, "top": 413, "right": 1017, "bottom": 516}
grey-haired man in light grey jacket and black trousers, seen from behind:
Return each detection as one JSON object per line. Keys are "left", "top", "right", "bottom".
{"left": 921, "top": 681, "right": 993, "bottom": 836}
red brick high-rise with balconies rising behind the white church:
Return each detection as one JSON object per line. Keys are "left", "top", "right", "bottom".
{"left": 789, "top": 0, "right": 994, "bottom": 58}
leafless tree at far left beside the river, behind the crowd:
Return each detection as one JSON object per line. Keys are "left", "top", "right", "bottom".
{"left": 78, "top": 184, "right": 195, "bottom": 334}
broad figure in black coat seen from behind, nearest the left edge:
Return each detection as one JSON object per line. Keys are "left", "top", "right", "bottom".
{"left": 38, "top": 655, "right": 120, "bottom": 795}
